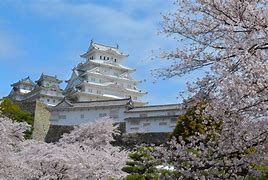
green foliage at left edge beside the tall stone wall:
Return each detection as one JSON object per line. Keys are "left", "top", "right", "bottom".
{"left": 0, "top": 98, "right": 34, "bottom": 139}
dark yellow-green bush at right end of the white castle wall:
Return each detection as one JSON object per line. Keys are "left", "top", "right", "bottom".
{"left": 171, "top": 105, "right": 222, "bottom": 142}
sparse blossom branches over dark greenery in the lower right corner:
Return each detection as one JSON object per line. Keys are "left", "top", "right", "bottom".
{"left": 153, "top": 116, "right": 268, "bottom": 179}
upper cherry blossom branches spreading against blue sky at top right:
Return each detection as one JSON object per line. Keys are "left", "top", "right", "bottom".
{"left": 157, "top": 0, "right": 268, "bottom": 120}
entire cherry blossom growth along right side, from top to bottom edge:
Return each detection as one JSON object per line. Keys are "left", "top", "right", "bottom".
{"left": 151, "top": 0, "right": 268, "bottom": 178}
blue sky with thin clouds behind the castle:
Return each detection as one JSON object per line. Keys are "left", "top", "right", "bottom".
{"left": 0, "top": 0, "right": 201, "bottom": 105}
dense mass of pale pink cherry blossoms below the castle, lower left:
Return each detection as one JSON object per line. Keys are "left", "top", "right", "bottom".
{"left": 0, "top": 118, "right": 127, "bottom": 179}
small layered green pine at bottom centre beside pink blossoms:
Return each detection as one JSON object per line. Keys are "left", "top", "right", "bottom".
{"left": 122, "top": 147, "right": 160, "bottom": 180}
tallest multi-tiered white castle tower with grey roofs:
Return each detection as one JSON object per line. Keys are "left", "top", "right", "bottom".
{"left": 65, "top": 41, "right": 146, "bottom": 105}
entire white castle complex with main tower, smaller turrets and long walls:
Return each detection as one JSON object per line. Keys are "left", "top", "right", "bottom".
{"left": 8, "top": 41, "right": 184, "bottom": 133}
